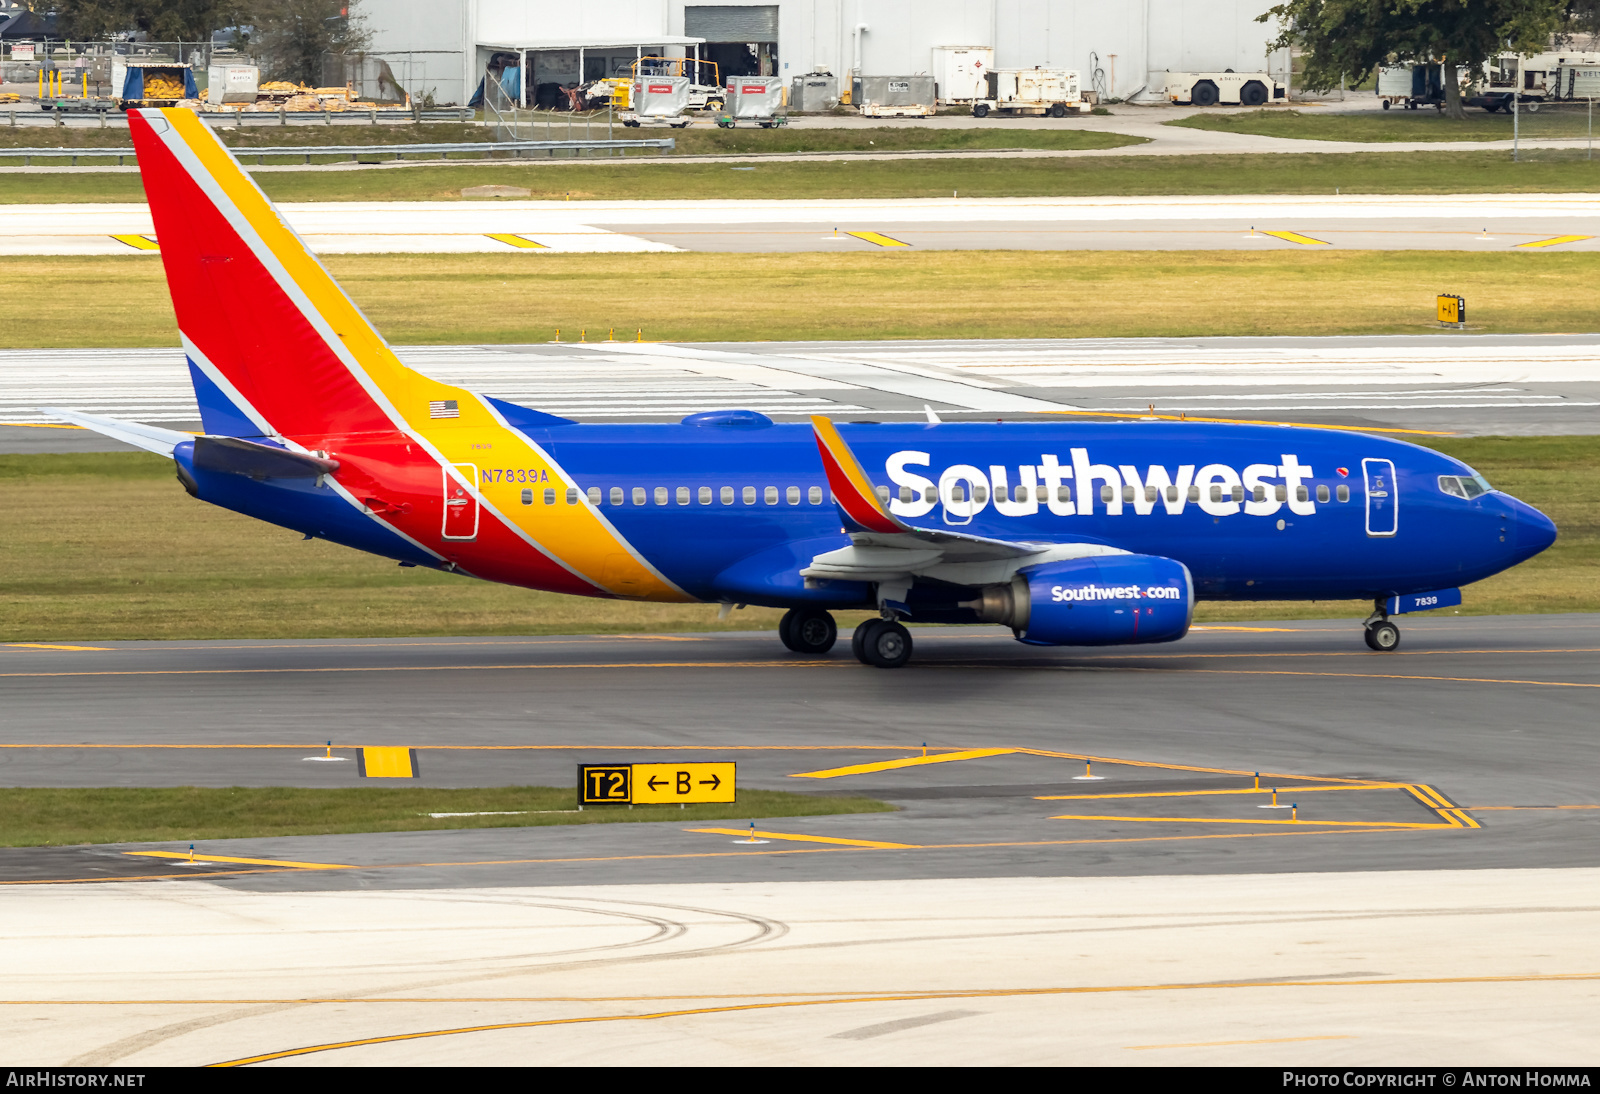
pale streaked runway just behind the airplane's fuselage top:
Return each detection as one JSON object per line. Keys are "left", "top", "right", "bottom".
{"left": 0, "top": 331, "right": 1600, "bottom": 453}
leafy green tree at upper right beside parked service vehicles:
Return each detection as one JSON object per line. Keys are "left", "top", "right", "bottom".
{"left": 1258, "top": 0, "right": 1568, "bottom": 118}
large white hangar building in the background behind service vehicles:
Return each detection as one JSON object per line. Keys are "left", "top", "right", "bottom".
{"left": 360, "top": 0, "right": 1288, "bottom": 104}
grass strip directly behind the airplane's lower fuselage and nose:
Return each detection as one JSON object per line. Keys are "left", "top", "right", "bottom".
{"left": 0, "top": 437, "right": 1600, "bottom": 641}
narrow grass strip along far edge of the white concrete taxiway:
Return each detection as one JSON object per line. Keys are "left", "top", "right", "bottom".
{"left": 9, "top": 147, "right": 1600, "bottom": 203}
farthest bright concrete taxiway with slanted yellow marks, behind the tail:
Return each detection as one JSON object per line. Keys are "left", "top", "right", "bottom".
{"left": 9, "top": 194, "right": 1600, "bottom": 258}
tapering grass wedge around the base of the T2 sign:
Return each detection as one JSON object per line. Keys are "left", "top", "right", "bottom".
{"left": 0, "top": 787, "right": 894, "bottom": 854}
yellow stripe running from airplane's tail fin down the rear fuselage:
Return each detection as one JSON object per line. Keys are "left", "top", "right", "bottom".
{"left": 162, "top": 107, "right": 693, "bottom": 603}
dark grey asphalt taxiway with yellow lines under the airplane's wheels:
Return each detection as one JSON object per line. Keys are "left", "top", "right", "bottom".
{"left": 0, "top": 616, "right": 1600, "bottom": 891}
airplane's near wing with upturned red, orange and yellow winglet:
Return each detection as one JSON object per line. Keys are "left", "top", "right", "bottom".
{"left": 800, "top": 416, "right": 1126, "bottom": 585}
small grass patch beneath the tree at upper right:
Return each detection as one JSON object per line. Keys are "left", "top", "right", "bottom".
{"left": 1165, "top": 106, "right": 1589, "bottom": 142}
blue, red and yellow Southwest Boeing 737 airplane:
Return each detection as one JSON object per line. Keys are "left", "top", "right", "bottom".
{"left": 56, "top": 109, "right": 1555, "bottom": 669}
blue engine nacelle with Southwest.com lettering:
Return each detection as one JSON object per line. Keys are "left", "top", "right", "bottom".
{"left": 966, "top": 555, "right": 1194, "bottom": 646}
